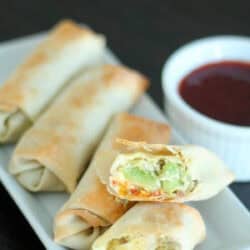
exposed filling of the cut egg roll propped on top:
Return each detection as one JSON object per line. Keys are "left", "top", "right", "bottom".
{"left": 110, "top": 152, "right": 197, "bottom": 200}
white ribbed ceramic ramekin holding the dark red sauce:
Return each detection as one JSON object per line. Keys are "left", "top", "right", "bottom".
{"left": 162, "top": 36, "right": 250, "bottom": 181}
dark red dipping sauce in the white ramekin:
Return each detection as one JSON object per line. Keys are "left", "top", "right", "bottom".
{"left": 179, "top": 61, "right": 250, "bottom": 126}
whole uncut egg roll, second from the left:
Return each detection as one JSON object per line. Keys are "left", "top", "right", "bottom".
{"left": 9, "top": 65, "right": 148, "bottom": 192}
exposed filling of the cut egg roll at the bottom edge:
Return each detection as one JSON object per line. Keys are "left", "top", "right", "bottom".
{"left": 107, "top": 235, "right": 181, "bottom": 250}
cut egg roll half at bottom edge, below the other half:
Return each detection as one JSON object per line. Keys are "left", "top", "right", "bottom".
{"left": 91, "top": 202, "right": 206, "bottom": 250}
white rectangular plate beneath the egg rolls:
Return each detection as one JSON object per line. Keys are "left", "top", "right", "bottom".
{"left": 0, "top": 34, "right": 250, "bottom": 250}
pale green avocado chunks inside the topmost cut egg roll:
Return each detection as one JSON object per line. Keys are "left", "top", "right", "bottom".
{"left": 119, "top": 158, "right": 193, "bottom": 197}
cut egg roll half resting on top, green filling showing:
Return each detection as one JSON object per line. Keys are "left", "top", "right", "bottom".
{"left": 108, "top": 139, "right": 234, "bottom": 202}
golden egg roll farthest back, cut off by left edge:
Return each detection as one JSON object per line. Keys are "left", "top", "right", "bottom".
{"left": 0, "top": 20, "right": 105, "bottom": 143}
